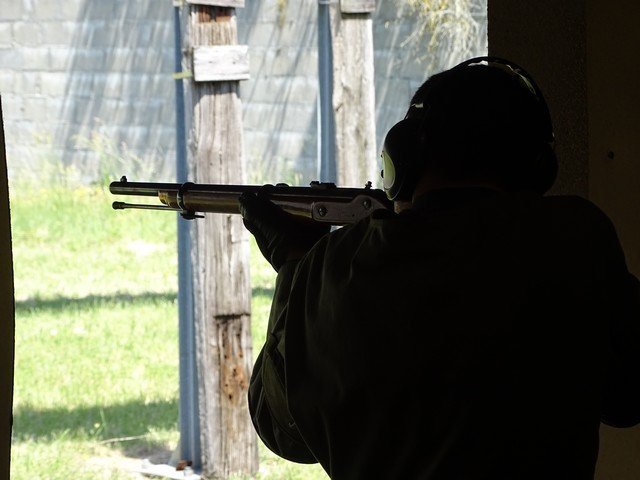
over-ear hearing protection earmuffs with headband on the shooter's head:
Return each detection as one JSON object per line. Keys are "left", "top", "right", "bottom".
{"left": 381, "top": 56, "right": 558, "bottom": 201}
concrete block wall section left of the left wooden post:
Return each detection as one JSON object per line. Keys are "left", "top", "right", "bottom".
{"left": 0, "top": 0, "right": 175, "bottom": 181}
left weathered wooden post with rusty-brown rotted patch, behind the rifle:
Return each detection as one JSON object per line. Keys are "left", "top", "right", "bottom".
{"left": 181, "top": 0, "right": 258, "bottom": 478}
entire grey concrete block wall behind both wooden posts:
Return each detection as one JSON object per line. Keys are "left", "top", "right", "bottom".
{"left": 0, "top": 0, "right": 486, "bottom": 184}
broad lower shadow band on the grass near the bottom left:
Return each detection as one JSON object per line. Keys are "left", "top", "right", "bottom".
{"left": 12, "top": 399, "right": 178, "bottom": 457}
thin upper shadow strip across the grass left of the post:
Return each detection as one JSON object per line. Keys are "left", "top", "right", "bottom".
{"left": 16, "top": 292, "right": 178, "bottom": 313}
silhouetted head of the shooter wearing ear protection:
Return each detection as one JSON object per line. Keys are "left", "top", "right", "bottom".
{"left": 383, "top": 57, "right": 557, "bottom": 201}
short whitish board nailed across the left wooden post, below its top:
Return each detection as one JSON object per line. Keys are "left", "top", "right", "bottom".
{"left": 193, "top": 45, "right": 249, "bottom": 82}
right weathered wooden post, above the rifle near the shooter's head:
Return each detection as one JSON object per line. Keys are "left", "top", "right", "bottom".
{"left": 331, "top": 0, "right": 380, "bottom": 187}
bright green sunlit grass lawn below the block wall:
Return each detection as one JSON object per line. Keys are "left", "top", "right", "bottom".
{"left": 11, "top": 186, "right": 327, "bottom": 480}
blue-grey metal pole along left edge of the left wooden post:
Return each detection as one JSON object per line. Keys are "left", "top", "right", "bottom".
{"left": 174, "top": 2, "right": 202, "bottom": 471}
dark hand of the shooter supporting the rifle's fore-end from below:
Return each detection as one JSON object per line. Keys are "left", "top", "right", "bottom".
{"left": 239, "top": 188, "right": 331, "bottom": 272}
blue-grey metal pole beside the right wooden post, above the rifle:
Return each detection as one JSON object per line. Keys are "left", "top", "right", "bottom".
{"left": 317, "top": 0, "right": 337, "bottom": 183}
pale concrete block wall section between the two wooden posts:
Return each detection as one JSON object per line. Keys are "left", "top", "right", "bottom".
{"left": 237, "top": 0, "right": 318, "bottom": 185}
